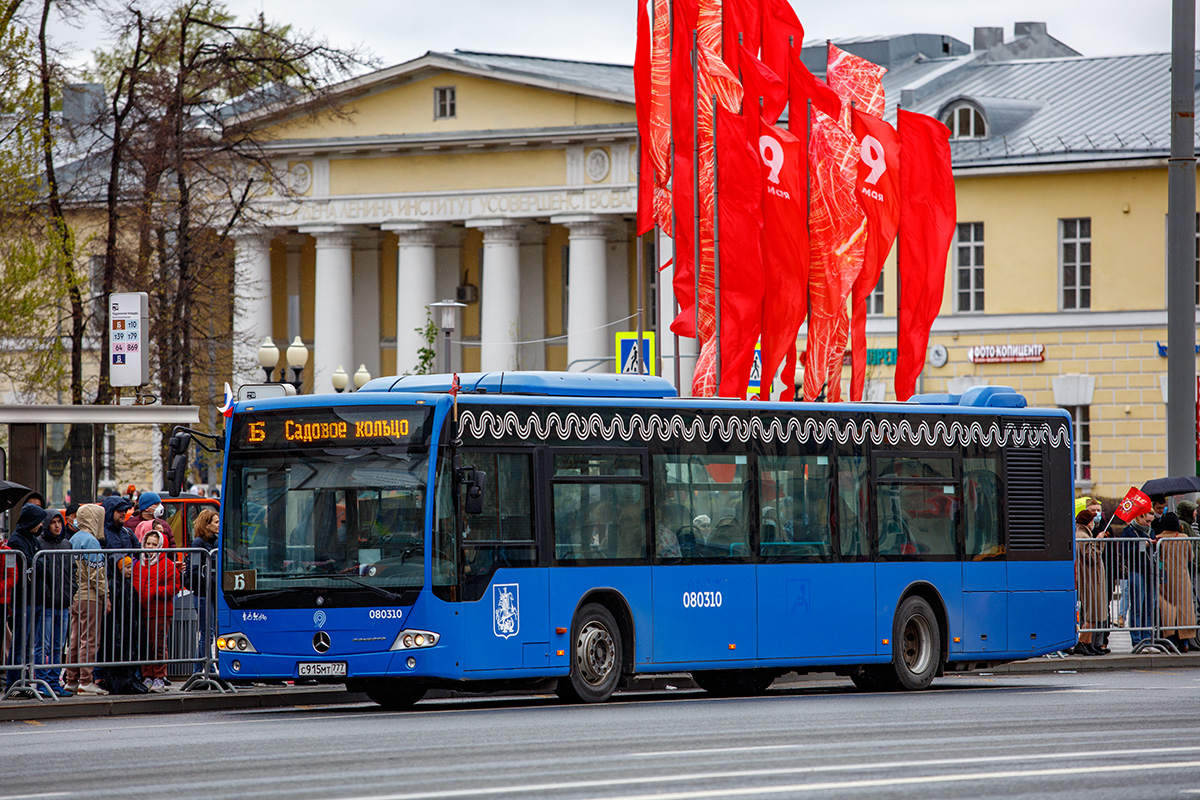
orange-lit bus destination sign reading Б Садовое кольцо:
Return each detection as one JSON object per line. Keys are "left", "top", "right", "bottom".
{"left": 234, "top": 408, "right": 432, "bottom": 450}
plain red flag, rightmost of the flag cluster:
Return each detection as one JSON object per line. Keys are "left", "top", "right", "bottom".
{"left": 895, "top": 109, "right": 955, "bottom": 401}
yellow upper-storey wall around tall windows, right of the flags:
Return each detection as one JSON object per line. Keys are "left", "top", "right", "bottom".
{"left": 950, "top": 169, "right": 1166, "bottom": 314}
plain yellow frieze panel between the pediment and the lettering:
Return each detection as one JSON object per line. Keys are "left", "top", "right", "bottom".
{"left": 329, "top": 149, "right": 566, "bottom": 196}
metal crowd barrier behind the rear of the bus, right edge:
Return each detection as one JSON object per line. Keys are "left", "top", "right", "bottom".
{"left": 1075, "top": 536, "right": 1200, "bottom": 654}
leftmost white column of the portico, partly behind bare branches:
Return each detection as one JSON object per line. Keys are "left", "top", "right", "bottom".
{"left": 233, "top": 233, "right": 271, "bottom": 386}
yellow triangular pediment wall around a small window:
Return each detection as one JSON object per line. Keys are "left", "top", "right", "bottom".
{"left": 265, "top": 72, "right": 635, "bottom": 139}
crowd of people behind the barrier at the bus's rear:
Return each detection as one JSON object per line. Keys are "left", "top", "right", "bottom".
{"left": 1070, "top": 495, "right": 1200, "bottom": 656}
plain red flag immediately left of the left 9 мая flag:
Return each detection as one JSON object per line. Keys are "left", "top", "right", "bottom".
{"left": 715, "top": 106, "right": 763, "bottom": 398}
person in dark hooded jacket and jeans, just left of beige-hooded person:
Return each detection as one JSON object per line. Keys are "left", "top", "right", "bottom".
{"left": 34, "top": 509, "right": 74, "bottom": 697}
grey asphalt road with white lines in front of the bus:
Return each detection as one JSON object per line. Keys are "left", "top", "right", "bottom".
{"left": 0, "top": 669, "right": 1200, "bottom": 800}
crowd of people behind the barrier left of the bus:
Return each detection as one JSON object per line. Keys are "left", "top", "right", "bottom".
{"left": 0, "top": 487, "right": 218, "bottom": 697}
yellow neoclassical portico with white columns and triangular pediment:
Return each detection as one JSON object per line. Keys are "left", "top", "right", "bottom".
{"left": 230, "top": 52, "right": 655, "bottom": 391}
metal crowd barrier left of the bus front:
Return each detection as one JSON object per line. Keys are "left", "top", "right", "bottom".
{"left": 0, "top": 547, "right": 232, "bottom": 700}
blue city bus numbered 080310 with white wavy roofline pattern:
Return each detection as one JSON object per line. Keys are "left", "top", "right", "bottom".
{"left": 206, "top": 372, "right": 1076, "bottom": 708}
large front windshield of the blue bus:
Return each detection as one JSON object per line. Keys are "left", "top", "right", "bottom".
{"left": 221, "top": 410, "right": 430, "bottom": 604}
